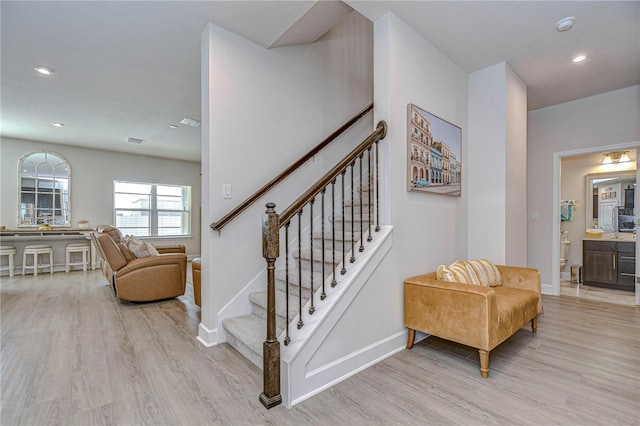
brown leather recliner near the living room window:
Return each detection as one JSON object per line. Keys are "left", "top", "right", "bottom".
{"left": 91, "top": 226, "right": 187, "bottom": 302}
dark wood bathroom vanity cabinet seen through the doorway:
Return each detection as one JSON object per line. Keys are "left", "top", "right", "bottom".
{"left": 582, "top": 238, "right": 636, "bottom": 291}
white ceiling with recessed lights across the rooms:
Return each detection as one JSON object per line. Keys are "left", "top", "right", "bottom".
{"left": 0, "top": 1, "right": 640, "bottom": 161}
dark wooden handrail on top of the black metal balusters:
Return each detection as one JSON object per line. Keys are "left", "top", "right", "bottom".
{"left": 279, "top": 121, "right": 387, "bottom": 226}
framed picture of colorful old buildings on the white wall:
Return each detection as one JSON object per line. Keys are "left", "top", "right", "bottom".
{"left": 407, "top": 104, "right": 462, "bottom": 197}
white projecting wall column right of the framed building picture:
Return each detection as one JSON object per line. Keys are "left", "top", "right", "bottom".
{"left": 468, "top": 62, "right": 527, "bottom": 266}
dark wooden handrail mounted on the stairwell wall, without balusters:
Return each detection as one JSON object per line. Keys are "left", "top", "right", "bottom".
{"left": 211, "top": 103, "right": 373, "bottom": 232}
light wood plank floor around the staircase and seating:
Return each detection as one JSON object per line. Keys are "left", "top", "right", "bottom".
{"left": 0, "top": 271, "right": 640, "bottom": 426}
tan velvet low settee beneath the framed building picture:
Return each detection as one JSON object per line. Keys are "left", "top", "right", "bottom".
{"left": 404, "top": 265, "right": 542, "bottom": 378}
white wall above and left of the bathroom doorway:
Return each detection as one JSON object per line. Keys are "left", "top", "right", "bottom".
{"left": 527, "top": 86, "right": 640, "bottom": 285}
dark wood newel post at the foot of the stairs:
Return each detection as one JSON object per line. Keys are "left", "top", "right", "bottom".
{"left": 260, "top": 203, "right": 282, "bottom": 409}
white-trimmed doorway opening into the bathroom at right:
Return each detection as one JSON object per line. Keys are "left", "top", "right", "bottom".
{"left": 551, "top": 142, "right": 640, "bottom": 305}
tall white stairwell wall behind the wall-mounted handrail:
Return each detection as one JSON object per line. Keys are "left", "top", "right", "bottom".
{"left": 200, "top": 12, "right": 373, "bottom": 344}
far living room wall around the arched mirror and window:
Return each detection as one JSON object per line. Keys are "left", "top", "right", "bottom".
{"left": 0, "top": 138, "right": 201, "bottom": 257}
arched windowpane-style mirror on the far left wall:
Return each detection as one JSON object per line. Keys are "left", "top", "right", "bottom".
{"left": 18, "top": 151, "right": 71, "bottom": 227}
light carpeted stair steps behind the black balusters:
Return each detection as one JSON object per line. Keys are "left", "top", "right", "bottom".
{"left": 222, "top": 191, "right": 374, "bottom": 369}
